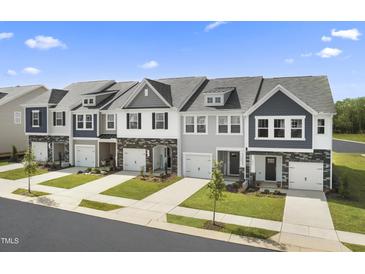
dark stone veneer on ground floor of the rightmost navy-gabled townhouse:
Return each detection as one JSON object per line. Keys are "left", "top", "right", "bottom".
{"left": 246, "top": 149, "right": 331, "bottom": 191}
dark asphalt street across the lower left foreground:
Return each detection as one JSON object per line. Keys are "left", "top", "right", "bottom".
{"left": 0, "top": 198, "right": 269, "bottom": 252}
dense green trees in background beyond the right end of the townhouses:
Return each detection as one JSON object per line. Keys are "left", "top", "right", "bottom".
{"left": 333, "top": 97, "right": 365, "bottom": 133}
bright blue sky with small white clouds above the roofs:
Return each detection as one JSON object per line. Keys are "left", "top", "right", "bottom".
{"left": 0, "top": 22, "right": 365, "bottom": 100}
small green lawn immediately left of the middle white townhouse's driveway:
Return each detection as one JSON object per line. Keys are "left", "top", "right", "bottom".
{"left": 41, "top": 174, "right": 102, "bottom": 189}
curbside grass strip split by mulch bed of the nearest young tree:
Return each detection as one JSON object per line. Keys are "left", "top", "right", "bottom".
{"left": 167, "top": 214, "right": 278, "bottom": 239}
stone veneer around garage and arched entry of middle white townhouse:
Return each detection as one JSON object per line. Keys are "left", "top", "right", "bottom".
{"left": 117, "top": 138, "right": 177, "bottom": 173}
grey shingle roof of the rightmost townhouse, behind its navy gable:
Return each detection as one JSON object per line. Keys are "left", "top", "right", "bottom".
{"left": 255, "top": 76, "right": 336, "bottom": 113}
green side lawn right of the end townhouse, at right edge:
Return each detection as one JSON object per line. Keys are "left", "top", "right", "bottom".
{"left": 328, "top": 153, "right": 365, "bottom": 234}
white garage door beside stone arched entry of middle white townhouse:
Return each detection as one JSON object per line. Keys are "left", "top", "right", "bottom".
{"left": 123, "top": 148, "right": 146, "bottom": 171}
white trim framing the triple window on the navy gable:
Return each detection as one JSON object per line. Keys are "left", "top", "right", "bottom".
{"left": 255, "top": 115, "right": 305, "bottom": 141}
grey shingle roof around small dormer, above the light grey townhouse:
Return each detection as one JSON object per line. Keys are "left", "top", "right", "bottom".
{"left": 182, "top": 76, "right": 262, "bottom": 111}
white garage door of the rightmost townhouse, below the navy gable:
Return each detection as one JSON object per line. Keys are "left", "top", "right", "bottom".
{"left": 289, "top": 162, "right": 323, "bottom": 191}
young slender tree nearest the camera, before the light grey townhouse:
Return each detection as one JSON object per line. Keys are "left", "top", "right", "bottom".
{"left": 208, "top": 161, "right": 226, "bottom": 225}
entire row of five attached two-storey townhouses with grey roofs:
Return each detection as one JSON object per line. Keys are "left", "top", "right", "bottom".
{"left": 24, "top": 76, "right": 335, "bottom": 190}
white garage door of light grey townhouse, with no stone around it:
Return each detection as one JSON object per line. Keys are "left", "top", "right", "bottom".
{"left": 184, "top": 154, "right": 212, "bottom": 179}
